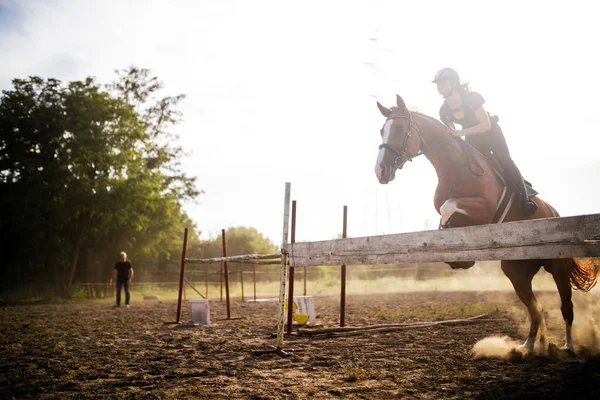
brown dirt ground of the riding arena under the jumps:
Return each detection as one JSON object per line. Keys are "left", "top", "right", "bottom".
{"left": 0, "top": 292, "right": 600, "bottom": 399}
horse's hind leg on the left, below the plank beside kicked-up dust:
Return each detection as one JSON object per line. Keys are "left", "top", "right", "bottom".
{"left": 501, "top": 260, "right": 544, "bottom": 351}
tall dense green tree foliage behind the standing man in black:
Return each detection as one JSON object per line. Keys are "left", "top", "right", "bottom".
{"left": 0, "top": 67, "right": 201, "bottom": 291}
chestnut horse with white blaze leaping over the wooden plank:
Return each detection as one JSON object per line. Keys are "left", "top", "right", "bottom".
{"left": 375, "top": 95, "right": 598, "bottom": 352}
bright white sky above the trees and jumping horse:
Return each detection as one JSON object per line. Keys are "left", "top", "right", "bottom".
{"left": 0, "top": 0, "right": 600, "bottom": 244}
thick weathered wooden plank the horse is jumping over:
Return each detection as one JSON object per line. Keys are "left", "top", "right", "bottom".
{"left": 284, "top": 214, "right": 600, "bottom": 267}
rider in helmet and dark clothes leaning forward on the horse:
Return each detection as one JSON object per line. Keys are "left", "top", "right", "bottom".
{"left": 433, "top": 68, "right": 537, "bottom": 216}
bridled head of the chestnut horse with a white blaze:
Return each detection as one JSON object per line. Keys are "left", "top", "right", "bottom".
{"left": 375, "top": 95, "right": 421, "bottom": 184}
